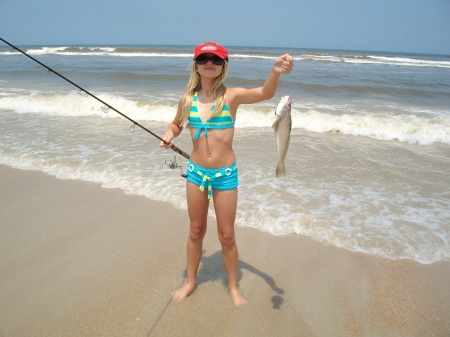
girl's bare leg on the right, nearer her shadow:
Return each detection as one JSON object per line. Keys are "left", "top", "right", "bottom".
{"left": 213, "top": 188, "right": 247, "bottom": 306}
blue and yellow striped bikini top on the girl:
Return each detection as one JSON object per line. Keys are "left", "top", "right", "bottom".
{"left": 188, "top": 91, "right": 234, "bottom": 139}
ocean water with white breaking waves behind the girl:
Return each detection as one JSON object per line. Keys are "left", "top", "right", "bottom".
{"left": 0, "top": 44, "right": 450, "bottom": 264}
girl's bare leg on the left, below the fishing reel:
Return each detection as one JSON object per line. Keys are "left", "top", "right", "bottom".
{"left": 172, "top": 182, "right": 209, "bottom": 302}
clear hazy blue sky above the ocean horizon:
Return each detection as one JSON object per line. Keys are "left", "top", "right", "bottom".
{"left": 0, "top": 0, "right": 450, "bottom": 55}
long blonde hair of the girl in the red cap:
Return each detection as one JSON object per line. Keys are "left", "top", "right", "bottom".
{"left": 180, "top": 57, "right": 228, "bottom": 128}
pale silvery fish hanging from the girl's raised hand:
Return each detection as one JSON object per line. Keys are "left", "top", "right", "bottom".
{"left": 272, "top": 96, "right": 292, "bottom": 178}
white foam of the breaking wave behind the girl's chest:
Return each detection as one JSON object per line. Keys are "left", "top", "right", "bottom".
{"left": 0, "top": 92, "right": 450, "bottom": 145}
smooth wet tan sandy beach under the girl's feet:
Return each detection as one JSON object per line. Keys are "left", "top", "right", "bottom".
{"left": 0, "top": 166, "right": 450, "bottom": 337}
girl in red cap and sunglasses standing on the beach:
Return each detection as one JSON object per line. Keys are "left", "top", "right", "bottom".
{"left": 160, "top": 42, "right": 293, "bottom": 306}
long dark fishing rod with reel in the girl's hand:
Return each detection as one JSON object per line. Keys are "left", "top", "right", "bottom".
{"left": 0, "top": 37, "right": 189, "bottom": 169}
